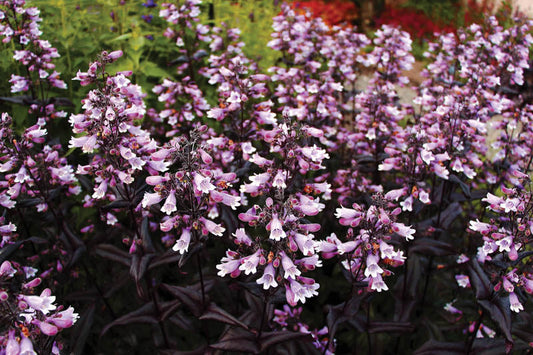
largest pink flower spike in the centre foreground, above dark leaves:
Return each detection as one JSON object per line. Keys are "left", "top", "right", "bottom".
{"left": 217, "top": 120, "right": 330, "bottom": 306}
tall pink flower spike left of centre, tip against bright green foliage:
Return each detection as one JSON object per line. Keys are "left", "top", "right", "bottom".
{"left": 69, "top": 51, "right": 161, "bottom": 206}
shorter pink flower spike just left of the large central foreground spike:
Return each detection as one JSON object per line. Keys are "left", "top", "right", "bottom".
{"left": 142, "top": 125, "right": 240, "bottom": 254}
